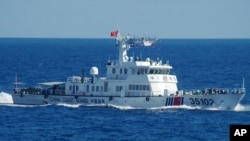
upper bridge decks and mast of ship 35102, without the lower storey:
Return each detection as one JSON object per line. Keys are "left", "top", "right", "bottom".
{"left": 106, "top": 33, "right": 175, "bottom": 80}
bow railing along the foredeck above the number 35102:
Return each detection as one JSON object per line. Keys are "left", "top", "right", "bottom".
{"left": 176, "top": 88, "right": 246, "bottom": 95}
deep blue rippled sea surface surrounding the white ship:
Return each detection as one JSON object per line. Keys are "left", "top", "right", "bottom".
{"left": 0, "top": 38, "right": 250, "bottom": 141}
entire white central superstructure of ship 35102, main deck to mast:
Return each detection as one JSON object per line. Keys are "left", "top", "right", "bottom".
{"left": 106, "top": 30, "right": 178, "bottom": 96}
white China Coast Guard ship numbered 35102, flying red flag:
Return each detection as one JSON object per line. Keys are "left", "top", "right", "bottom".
{"left": 12, "top": 31, "right": 246, "bottom": 110}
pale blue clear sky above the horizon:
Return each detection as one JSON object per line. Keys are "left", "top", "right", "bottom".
{"left": 0, "top": 0, "right": 250, "bottom": 38}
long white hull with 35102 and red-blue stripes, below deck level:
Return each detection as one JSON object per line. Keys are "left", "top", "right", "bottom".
{"left": 13, "top": 94, "right": 244, "bottom": 110}
